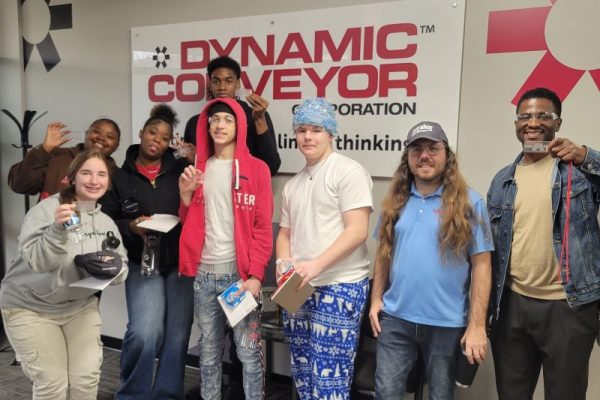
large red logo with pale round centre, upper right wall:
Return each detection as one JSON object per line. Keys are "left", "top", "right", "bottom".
{"left": 486, "top": 0, "right": 600, "bottom": 105}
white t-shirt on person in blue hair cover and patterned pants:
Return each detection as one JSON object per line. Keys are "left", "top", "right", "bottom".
{"left": 279, "top": 153, "right": 373, "bottom": 286}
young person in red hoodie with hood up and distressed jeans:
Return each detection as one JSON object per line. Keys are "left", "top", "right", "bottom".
{"left": 179, "top": 99, "right": 273, "bottom": 400}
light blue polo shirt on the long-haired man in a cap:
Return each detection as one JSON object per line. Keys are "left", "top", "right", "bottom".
{"left": 383, "top": 184, "right": 494, "bottom": 328}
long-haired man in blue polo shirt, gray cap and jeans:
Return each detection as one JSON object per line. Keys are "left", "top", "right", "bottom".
{"left": 369, "top": 121, "right": 493, "bottom": 400}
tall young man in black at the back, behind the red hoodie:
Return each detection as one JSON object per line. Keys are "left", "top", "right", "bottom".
{"left": 184, "top": 56, "right": 281, "bottom": 176}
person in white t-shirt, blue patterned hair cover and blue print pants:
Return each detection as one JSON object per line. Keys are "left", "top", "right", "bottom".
{"left": 276, "top": 99, "right": 373, "bottom": 399}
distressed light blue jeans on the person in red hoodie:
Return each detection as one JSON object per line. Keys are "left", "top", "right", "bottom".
{"left": 194, "top": 270, "right": 265, "bottom": 400}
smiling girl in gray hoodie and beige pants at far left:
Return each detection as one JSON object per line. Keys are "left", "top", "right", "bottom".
{"left": 0, "top": 150, "right": 127, "bottom": 400}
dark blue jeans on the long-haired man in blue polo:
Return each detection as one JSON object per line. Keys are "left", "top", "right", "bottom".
{"left": 375, "top": 312, "right": 465, "bottom": 400}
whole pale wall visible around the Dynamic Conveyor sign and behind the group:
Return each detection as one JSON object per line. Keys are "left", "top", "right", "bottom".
{"left": 0, "top": 0, "right": 600, "bottom": 400}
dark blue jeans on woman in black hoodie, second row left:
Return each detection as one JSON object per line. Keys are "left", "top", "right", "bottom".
{"left": 116, "top": 262, "right": 194, "bottom": 400}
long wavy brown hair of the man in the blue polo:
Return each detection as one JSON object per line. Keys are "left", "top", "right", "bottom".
{"left": 376, "top": 147, "right": 476, "bottom": 267}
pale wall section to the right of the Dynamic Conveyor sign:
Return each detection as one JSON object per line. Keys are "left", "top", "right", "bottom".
{"left": 458, "top": 0, "right": 600, "bottom": 400}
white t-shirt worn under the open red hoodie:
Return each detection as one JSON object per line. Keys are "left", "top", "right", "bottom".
{"left": 201, "top": 157, "right": 235, "bottom": 264}
